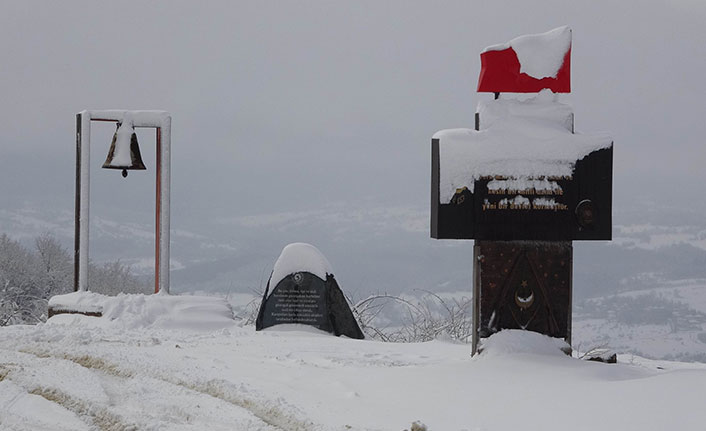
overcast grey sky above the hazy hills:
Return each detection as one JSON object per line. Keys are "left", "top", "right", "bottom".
{"left": 0, "top": 0, "right": 706, "bottom": 294}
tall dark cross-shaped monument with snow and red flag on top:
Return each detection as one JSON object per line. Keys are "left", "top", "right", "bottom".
{"left": 431, "top": 27, "right": 613, "bottom": 354}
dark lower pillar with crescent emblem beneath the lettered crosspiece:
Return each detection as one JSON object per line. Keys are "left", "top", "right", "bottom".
{"left": 472, "top": 240, "right": 573, "bottom": 355}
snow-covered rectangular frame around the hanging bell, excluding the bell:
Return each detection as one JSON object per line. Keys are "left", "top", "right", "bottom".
{"left": 74, "top": 110, "right": 172, "bottom": 294}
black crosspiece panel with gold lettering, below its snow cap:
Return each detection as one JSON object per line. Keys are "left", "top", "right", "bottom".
{"left": 431, "top": 143, "right": 613, "bottom": 241}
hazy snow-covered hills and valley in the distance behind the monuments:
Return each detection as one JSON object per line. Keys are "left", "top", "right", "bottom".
{"left": 0, "top": 202, "right": 706, "bottom": 361}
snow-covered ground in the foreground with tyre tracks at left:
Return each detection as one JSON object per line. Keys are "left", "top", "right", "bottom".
{"left": 0, "top": 295, "right": 706, "bottom": 431}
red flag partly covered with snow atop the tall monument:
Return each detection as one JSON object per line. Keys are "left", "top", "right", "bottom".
{"left": 478, "top": 26, "right": 571, "bottom": 93}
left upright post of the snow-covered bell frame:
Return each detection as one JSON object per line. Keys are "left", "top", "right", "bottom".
{"left": 74, "top": 111, "right": 91, "bottom": 291}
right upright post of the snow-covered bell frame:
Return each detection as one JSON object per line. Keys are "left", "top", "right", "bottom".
{"left": 157, "top": 116, "right": 172, "bottom": 294}
